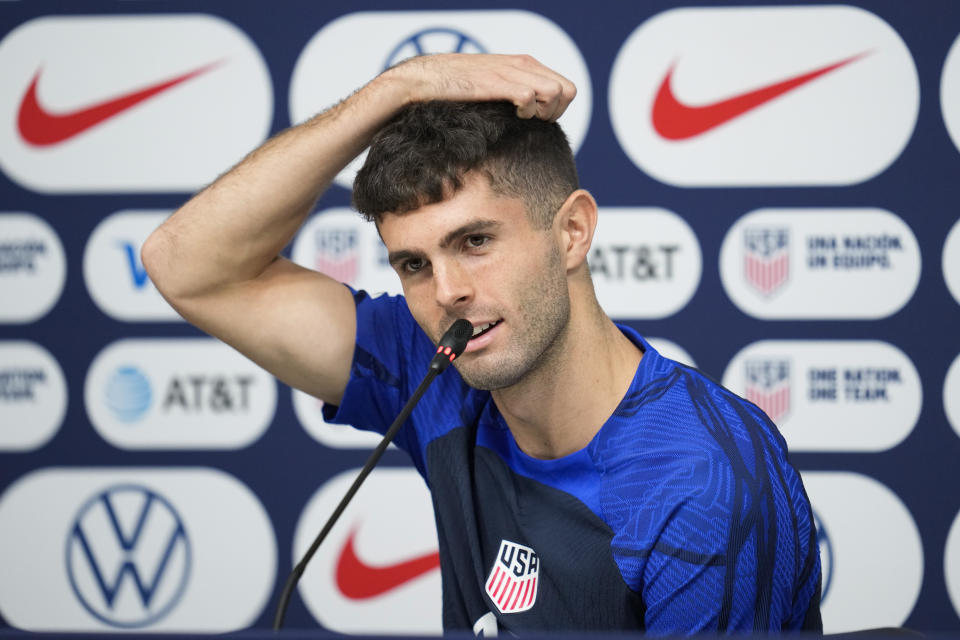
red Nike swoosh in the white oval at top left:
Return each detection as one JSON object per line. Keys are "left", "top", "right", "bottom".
{"left": 17, "top": 61, "right": 222, "bottom": 147}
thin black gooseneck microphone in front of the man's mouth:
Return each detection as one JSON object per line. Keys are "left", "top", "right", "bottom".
{"left": 273, "top": 318, "right": 473, "bottom": 631}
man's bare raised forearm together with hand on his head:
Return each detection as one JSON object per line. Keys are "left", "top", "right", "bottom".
{"left": 143, "top": 54, "right": 576, "bottom": 300}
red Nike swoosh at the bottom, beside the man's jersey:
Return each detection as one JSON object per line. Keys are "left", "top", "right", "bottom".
{"left": 336, "top": 530, "right": 440, "bottom": 600}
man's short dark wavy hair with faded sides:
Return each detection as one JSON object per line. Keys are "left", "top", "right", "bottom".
{"left": 353, "top": 101, "right": 579, "bottom": 229}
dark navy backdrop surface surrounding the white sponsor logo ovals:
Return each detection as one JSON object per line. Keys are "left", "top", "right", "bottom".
{"left": 0, "top": 0, "right": 960, "bottom": 630}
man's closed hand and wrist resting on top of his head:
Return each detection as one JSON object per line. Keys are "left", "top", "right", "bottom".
{"left": 381, "top": 53, "right": 577, "bottom": 121}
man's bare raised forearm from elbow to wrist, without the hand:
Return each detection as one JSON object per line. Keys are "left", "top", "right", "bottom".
{"left": 143, "top": 71, "right": 406, "bottom": 298}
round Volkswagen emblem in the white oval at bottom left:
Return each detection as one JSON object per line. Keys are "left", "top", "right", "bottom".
{"left": 66, "top": 484, "right": 191, "bottom": 628}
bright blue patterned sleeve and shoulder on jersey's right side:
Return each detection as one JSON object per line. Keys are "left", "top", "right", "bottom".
{"left": 606, "top": 362, "right": 820, "bottom": 635}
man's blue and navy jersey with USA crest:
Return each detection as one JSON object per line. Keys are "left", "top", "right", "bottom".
{"left": 324, "top": 292, "right": 822, "bottom": 634}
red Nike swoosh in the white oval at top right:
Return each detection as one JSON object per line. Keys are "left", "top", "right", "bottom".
{"left": 652, "top": 51, "right": 870, "bottom": 140}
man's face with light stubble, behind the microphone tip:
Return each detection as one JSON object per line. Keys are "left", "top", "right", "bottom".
{"left": 379, "top": 174, "right": 570, "bottom": 390}
